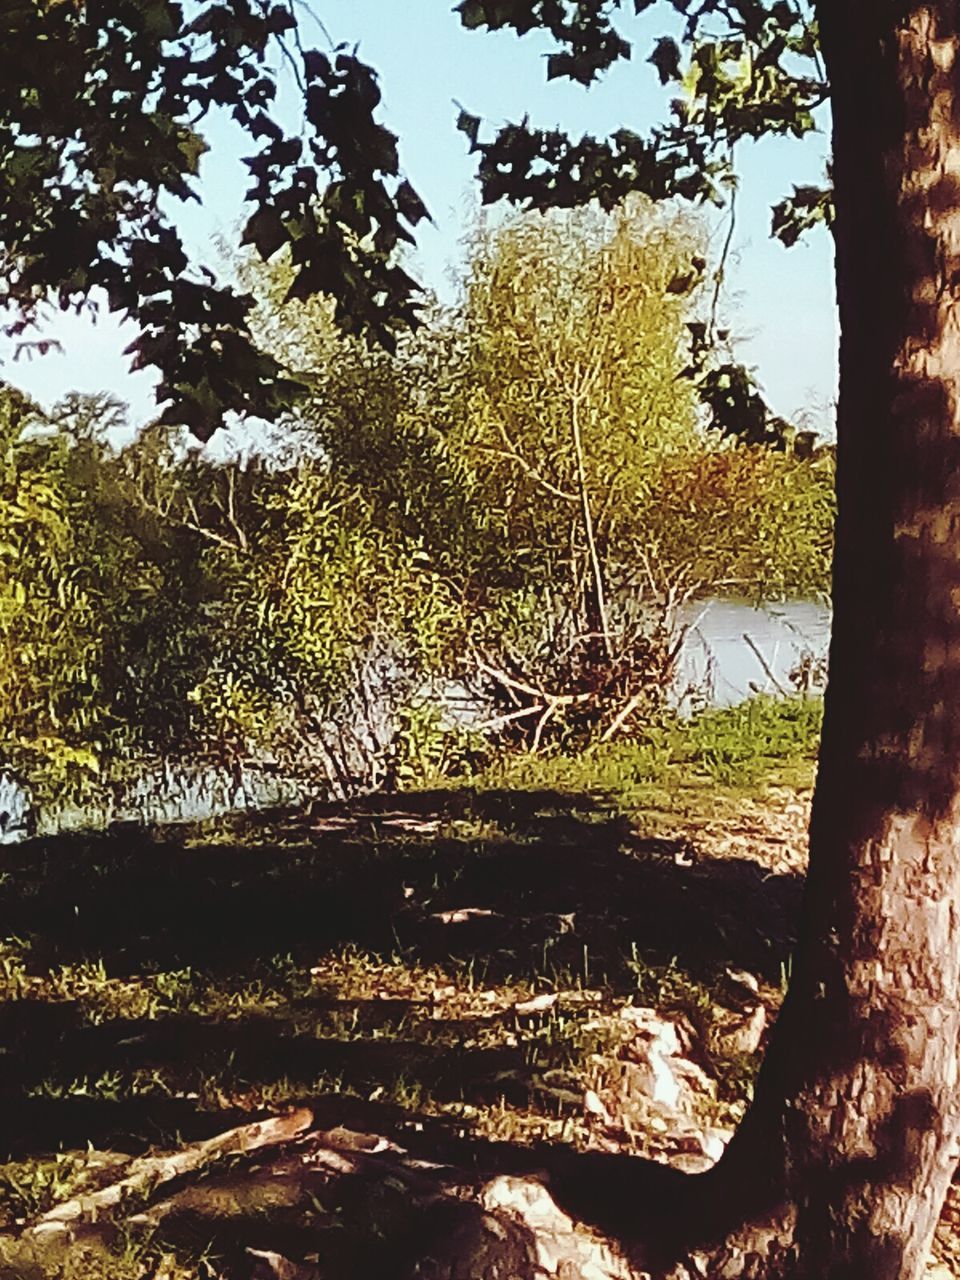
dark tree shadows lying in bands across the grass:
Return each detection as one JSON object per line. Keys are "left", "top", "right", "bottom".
{"left": 0, "top": 791, "right": 800, "bottom": 1160}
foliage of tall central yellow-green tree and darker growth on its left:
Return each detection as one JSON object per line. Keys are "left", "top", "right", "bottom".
{"left": 241, "top": 204, "right": 716, "bottom": 733}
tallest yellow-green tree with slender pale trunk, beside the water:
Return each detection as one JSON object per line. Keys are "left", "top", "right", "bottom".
{"left": 466, "top": 204, "right": 694, "bottom": 662}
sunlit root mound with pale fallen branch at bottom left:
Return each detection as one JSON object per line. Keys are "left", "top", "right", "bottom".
{"left": 0, "top": 1110, "right": 669, "bottom": 1280}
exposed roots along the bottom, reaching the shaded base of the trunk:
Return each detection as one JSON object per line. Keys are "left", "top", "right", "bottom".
{"left": 7, "top": 1108, "right": 960, "bottom": 1280}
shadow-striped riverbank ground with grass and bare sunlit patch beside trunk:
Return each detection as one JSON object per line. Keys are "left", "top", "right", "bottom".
{"left": 0, "top": 705, "right": 957, "bottom": 1280}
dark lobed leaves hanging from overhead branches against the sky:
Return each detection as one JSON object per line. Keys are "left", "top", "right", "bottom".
{"left": 0, "top": 0, "right": 832, "bottom": 439}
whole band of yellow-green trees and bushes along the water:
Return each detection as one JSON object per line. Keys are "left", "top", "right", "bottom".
{"left": 0, "top": 205, "right": 832, "bottom": 792}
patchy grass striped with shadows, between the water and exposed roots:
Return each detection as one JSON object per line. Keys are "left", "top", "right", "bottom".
{"left": 0, "top": 701, "right": 819, "bottom": 1277}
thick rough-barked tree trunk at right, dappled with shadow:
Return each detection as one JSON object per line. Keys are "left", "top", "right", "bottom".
{"left": 716, "top": 0, "right": 960, "bottom": 1280}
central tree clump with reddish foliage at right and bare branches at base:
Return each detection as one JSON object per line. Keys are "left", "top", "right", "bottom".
{"left": 237, "top": 200, "right": 832, "bottom": 749}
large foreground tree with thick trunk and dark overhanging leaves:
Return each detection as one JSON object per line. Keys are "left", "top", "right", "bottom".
{"left": 0, "top": 0, "right": 960, "bottom": 1280}
